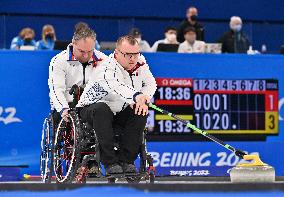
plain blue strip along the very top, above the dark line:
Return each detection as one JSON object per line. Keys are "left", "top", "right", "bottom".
{"left": 0, "top": 0, "right": 284, "bottom": 21}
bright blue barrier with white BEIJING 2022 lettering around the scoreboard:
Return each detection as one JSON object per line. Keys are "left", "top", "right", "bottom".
{"left": 0, "top": 51, "right": 284, "bottom": 175}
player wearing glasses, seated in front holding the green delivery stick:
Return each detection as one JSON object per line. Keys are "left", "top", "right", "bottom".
{"left": 76, "top": 36, "right": 157, "bottom": 175}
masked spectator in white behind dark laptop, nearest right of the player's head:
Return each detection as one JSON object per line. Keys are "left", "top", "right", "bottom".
{"left": 151, "top": 27, "right": 179, "bottom": 52}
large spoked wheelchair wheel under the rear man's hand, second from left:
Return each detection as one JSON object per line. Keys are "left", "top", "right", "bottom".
{"left": 54, "top": 111, "right": 80, "bottom": 183}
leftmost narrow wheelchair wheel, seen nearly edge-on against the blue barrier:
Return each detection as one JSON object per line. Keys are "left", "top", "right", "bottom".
{"left": 40, "top": 114, "right": 54, "bottom": 183}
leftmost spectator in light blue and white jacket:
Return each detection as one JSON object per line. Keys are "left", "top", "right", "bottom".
{"left": 10, "top": 27, "right": 36, "bottom": 50}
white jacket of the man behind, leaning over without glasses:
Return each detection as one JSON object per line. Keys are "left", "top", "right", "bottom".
{"left": 48, "top": 45, "right": 107, "bottom": 112}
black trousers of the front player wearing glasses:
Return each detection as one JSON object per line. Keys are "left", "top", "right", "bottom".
{"left": 80, "top": 103, "right": 147, "bottom": 166}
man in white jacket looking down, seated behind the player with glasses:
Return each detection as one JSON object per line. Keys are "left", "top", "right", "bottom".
{"left": 48, "top": 26, "right": 107, "bottom": 175}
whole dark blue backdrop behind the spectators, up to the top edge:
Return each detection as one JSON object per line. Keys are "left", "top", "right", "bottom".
{"left": 0, "top": 0, "right": 284, "bottom": 53}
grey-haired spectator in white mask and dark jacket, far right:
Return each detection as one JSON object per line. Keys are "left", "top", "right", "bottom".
{"left": 217, "top": 16, "right": 250, "bottom": 53}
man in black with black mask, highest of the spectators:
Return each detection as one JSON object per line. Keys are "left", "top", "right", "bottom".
{"left": 177, "top": 7, "right": 204, "bottom": 43}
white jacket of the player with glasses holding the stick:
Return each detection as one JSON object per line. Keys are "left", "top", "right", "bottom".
{"left": 77, "top": 54, "right": 157, "bottom": 113}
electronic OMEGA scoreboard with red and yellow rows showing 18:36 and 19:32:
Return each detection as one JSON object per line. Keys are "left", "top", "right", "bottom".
{"left": 148, "top": 78, "right": 278, "bottom": 139}
